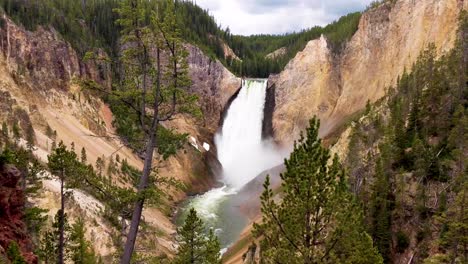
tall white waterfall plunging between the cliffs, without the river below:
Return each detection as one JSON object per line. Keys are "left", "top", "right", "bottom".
{"left": 215, "top": 79, "right": 282, "bottom": 189}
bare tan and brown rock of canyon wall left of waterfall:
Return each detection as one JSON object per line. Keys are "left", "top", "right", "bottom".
{"left": 0, "top": 12, "right": 241, "bottom": 256}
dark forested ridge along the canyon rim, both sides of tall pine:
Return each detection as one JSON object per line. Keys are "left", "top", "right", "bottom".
{"left": 0, "top": 0, "right": 361, "bottom": 78}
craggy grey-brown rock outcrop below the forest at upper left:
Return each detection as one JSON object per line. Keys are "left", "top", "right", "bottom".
{"left": 0, "top": 16, "right": 111, "bottom": 91}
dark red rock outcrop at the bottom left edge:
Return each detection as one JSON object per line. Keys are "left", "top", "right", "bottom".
{"left": 0, "top": 164, "right": 38, "bottom": 263}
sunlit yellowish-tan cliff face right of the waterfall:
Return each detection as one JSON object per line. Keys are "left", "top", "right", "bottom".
{"left": 270, "top": 0, "right": 468, "bottom": 144}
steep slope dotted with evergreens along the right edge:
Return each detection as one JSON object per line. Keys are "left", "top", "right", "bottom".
{"left": 346, "top": 12, "right": 468, "bottom": 263}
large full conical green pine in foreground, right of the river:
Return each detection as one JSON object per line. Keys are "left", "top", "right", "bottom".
{"left": 254, "top": 118, "right": 382, "bottom": 263}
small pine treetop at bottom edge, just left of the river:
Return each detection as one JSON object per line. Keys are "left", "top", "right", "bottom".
{"left": 174, "top": 208, "right": 221, "bottom": 264}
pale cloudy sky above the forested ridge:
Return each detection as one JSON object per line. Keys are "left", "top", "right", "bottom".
{"left": 195, "top": 0, "right": 372, "bottom": 35}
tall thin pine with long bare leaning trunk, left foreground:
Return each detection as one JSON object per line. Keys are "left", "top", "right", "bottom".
{"left": 115, "top": 0, "right": 200, "bottom": 264}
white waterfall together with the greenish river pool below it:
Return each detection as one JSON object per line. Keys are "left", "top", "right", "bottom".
{"left": 177, "top": 80, "right": 285, "bottom": 251}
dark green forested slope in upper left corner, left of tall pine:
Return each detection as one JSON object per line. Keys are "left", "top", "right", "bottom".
{"left": 0, "top": 0, "right": 119, "bottom": 55}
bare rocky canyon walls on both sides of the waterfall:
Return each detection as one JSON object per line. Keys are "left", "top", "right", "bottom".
{"left": 0, "top": 0, "right": 468, "bottom": 263}
